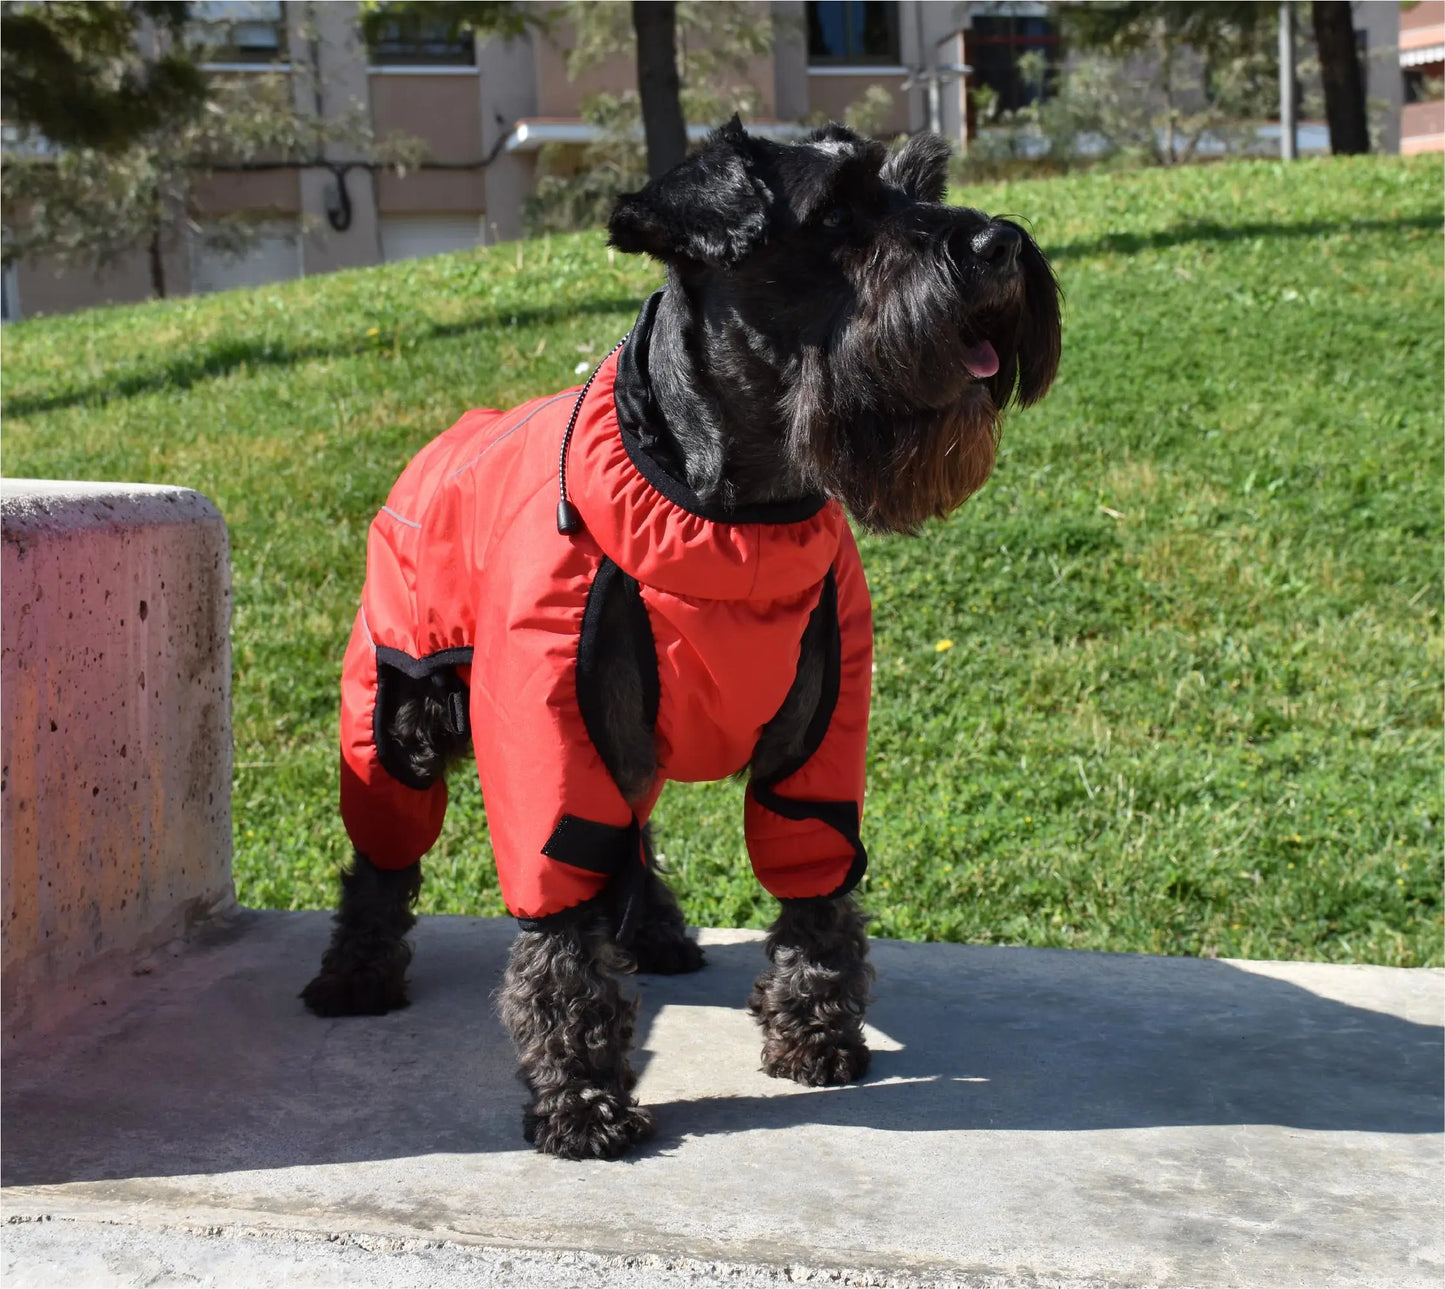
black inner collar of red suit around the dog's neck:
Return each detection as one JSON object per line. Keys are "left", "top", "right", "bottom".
{"left": 613, "top": 290, "right": 828, "bottom": 523}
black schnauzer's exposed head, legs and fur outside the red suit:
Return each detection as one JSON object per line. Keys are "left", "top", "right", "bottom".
{"left": 302, "top": 118, "right": 1059, "bottom": 1159}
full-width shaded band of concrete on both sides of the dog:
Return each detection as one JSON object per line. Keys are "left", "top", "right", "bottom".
{"left": 0, "top": 913, "right": 1445, "bottom": 1186}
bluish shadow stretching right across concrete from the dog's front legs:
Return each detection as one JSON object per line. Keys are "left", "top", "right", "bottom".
{"left": 627, "top": 941, "right": 1445, "bottom": 1150}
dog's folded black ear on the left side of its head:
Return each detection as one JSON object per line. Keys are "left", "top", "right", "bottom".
{"left": 607, "top": 116, "right": 772, "bottom": 267}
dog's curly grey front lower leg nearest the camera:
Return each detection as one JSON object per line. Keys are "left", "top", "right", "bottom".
{"left": 497, "top": 916, "right": 653, "bottom": 1159}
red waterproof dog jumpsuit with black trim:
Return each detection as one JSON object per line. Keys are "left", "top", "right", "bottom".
{"left": 341, "top": 296, "right": 873, "bottom": 925}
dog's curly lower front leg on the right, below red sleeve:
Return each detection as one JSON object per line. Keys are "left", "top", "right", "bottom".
{"left": 747, "top": 896, "right": 874, "bottom": 1087}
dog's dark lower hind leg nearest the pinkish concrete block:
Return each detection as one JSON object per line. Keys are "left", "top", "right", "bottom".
{"left": 301, "top": 851, "right": 422, "bottom": 1016}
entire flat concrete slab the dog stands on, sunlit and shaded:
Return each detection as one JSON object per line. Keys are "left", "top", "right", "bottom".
{"left": 0, "top": 913, "right": 1445, "bottom": 1289}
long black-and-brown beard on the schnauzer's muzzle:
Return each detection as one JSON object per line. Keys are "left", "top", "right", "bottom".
{"left": 788, "top": 236, "right": 1059, "bottom": 533}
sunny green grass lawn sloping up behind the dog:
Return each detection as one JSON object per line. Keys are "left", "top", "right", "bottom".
{"left": 3, "top": 158, "right": 1445, "bottom": 965}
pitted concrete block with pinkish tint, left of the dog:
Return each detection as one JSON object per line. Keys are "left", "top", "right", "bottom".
{"left": 0, "top": 480, "right": 234, "bottom": 1033}
